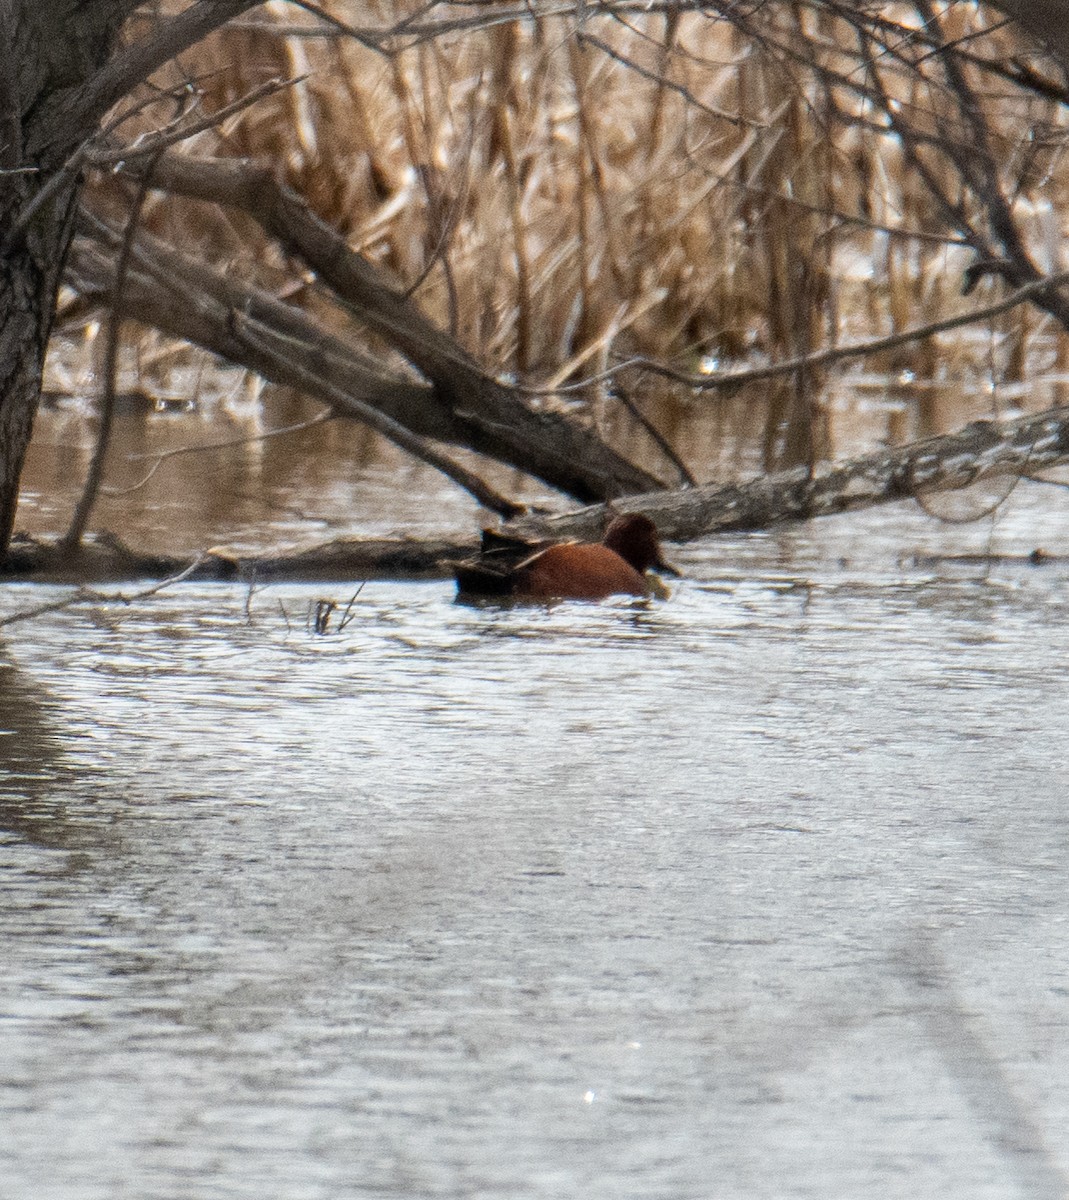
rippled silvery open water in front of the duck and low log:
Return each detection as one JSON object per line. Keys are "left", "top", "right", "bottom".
{"left": 0, "top": 493, "right": 1069, "bottom": 1200}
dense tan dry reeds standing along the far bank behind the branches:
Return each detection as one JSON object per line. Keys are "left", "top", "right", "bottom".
{"left": 60, "top": 0, "right": 1067, "bottom": 477}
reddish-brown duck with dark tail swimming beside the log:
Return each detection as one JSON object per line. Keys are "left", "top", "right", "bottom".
{"left": 454, "top": 512, "right": 679, "bottom": 602}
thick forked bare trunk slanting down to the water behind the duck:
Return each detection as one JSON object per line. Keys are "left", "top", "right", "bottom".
{"left": 68, "top": 155, "right": 659, "bottom": 500}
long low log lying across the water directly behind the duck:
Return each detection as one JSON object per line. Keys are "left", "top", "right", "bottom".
{"left": 12, "top": 408, "right": 1069, "bottom": 582}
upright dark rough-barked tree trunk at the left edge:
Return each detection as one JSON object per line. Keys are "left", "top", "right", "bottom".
{"left": 0, "top": 0, "right": 259, "bottom": 557}
